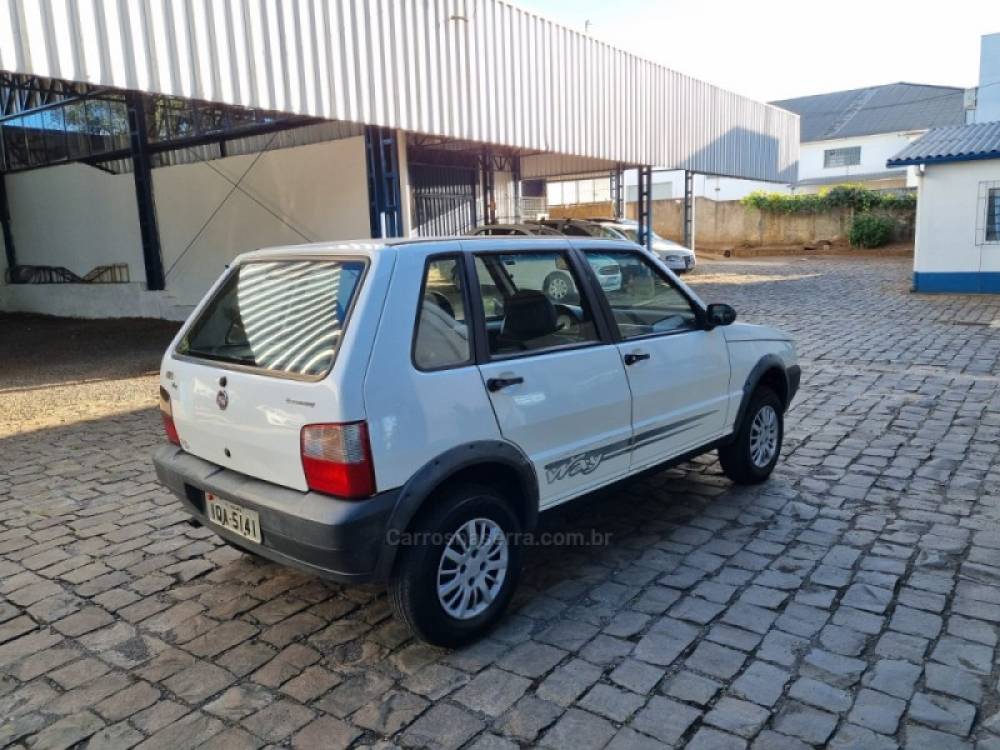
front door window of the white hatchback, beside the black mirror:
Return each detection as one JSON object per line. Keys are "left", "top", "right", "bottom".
{"left": 586, "top": 252, "right": 699, "bottom": 339}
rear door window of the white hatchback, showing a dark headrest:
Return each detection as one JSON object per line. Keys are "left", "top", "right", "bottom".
{"left": 476, "top": 252, "right": 599, "bottom": 357}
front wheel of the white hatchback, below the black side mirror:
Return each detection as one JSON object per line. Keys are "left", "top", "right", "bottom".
{"left": 719, "top": 386, "right": 785, "bottom": 484}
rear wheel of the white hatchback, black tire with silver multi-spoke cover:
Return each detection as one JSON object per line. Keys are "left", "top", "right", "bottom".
{"left": 388, "top": 484, "right": 521, "bottom": 648}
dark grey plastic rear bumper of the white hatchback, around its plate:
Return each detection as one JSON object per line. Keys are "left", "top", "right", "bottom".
{"left": 153, "top": 445, "right": 400, "bottom": 583}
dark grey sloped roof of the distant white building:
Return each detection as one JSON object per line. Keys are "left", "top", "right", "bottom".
{"left": 771, "top": 83, "right": 965, "bottom": 143}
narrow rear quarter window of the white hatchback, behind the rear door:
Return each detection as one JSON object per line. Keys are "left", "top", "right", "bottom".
{"left": 413, "top": 257, "right": 472, "bottom": 370}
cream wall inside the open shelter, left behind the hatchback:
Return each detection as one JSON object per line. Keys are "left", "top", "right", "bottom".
{"left": 0, "top": 137, "right": 371, "bottom": 317}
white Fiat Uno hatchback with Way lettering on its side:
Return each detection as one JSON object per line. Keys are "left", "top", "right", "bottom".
{"left": 154, "top": 237, "right": 800, "bottom": 646}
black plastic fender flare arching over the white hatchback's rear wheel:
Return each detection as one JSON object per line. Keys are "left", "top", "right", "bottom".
{"left": 378, "top": 440, "right": 539, "bottom": 579}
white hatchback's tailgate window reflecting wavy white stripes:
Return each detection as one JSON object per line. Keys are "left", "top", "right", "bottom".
{"left": 177, "top": 260, "right": 365, "bottom": 377}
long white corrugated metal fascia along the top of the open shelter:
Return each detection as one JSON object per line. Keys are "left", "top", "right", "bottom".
{"left": 0, "top": 0, "right": 798, "bottom": 181}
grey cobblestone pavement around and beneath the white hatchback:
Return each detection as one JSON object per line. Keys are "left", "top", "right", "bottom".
{"left": 0, "top": 259, "right": 1000, "bottom": 750}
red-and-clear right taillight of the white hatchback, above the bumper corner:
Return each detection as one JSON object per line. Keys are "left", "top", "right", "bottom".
{"left": 302, "top": 422, "right": 375, "bottom": 499}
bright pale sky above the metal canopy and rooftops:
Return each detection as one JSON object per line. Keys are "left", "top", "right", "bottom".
{"left": 512, "top": 0, "right": 1000, "bottom": 101}
